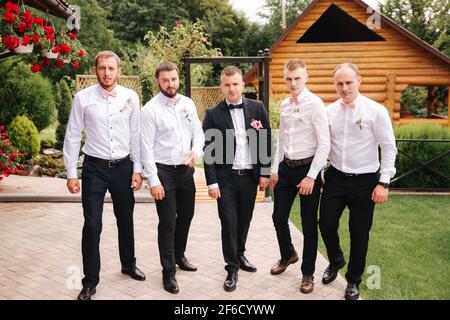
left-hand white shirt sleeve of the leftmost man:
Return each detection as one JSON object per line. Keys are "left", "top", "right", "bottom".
{"left": 63, "top": 95, "right": 84, "bottom": 179}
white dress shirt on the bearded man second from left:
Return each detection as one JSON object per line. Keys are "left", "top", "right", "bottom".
{"left": 141, "top": 93, "right": 205, "bottom": 187}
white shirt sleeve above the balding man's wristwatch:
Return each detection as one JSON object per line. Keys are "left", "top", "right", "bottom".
{"left": 375, "top": 107, "right": 397, "bottom": 183}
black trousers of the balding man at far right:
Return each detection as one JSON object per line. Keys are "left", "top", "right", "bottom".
{"left": 319, "top": 167, "right": 379, "bottom": 284}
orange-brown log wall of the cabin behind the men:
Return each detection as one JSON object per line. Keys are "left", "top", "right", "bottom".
{"left": 246, "top": 0, "right": 450, "bottom": 126}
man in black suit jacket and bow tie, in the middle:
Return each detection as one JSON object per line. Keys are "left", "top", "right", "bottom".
{"left": 203, "top": 66, "right": 271, "bottom": 292}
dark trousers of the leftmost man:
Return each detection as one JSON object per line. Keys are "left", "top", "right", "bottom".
{"left": 81, "top": 158, "right": 136, "bottom": 288}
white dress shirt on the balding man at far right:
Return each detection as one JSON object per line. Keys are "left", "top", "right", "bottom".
{"left": 326, "top": 94, "right": 397, "bottom": 183}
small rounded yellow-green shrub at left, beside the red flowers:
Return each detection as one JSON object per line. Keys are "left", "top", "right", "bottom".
{"left": 8, "top": 116, "right": 41, "bottom": 159}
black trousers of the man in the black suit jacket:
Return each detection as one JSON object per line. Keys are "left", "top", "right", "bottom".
{"left": 217, "top": 170, "right": 257, "bottom": 272}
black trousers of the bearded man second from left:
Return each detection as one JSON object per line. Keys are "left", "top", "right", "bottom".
{"left": 156, "top": 163, "right": 195, "bottom": 276}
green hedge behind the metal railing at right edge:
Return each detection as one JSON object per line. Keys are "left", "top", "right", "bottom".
{"left": 392, "top": 123, "right": 450, "bottom": 188}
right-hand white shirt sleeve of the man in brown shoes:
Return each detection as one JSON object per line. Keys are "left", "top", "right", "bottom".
{"left": 307, "top": 103, "right": 330, "bottom": 180}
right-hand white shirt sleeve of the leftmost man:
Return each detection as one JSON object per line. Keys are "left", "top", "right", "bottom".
{"left": 130, "top": 93, "right": 142, "bottom": 173}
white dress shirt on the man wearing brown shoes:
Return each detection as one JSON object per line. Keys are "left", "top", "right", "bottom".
{"left": 272, "top": 88, "right": 330, "bottom": 179}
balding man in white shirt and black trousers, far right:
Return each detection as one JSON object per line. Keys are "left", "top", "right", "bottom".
{"left": 319, "top": 63, "right": 397, "bottom": 300}
